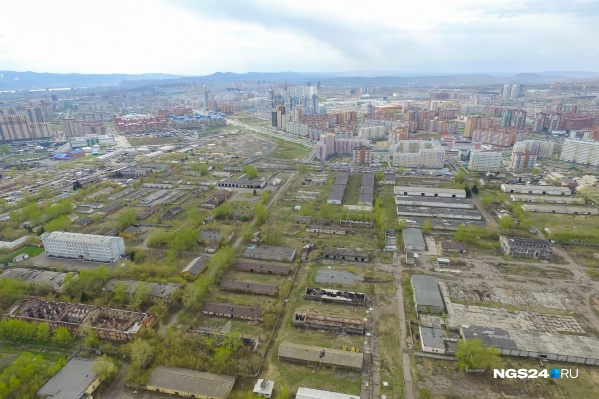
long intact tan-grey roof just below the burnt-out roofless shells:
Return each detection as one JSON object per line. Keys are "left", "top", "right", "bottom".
{"left": 278, "top": 342, "right": 364, "bottom": 369}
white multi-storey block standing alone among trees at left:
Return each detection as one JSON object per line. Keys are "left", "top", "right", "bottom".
{"left": 40, "top": 231, "right": 125, "bottom": 262}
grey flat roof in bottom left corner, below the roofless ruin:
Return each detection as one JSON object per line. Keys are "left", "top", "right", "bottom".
{"left": 37, "top": 358, "right": 97, "bottom": 399}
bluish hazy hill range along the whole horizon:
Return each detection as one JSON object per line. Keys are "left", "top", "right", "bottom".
{"left": 0, "top": 71, "right": 599, "bottom": 90}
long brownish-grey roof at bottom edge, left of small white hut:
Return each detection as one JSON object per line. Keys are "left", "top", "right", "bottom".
{"left": 147, "top": 366, "right": 235, "bottom": 399}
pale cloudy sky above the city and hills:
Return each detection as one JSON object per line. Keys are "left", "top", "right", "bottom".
{"left": 0, "top": 0, "right": 599, "bottom": 75}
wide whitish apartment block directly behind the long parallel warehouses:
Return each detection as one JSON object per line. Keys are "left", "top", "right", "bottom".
{"left": 390, "top": 140, "right": 445, "bottom": 168}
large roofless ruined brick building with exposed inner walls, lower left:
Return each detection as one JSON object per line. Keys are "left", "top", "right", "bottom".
{"left": 4, "top": 298, "right": 155, "bottom": 341}
